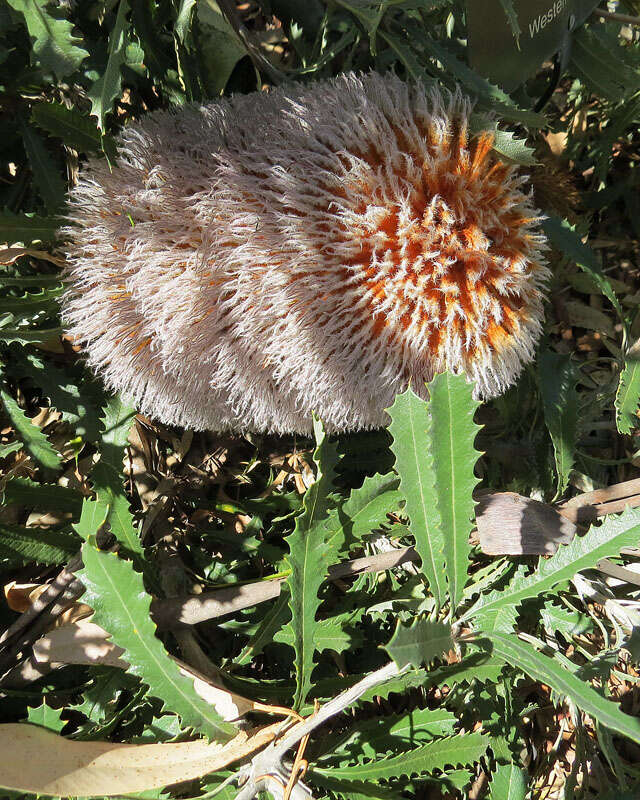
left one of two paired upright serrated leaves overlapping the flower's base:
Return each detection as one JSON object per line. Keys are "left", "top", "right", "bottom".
{"left": 388, "top": 388, "right": 446, "bottom": 606}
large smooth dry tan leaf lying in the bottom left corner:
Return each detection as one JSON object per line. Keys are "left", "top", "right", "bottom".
{"left": 0, "top": 723, "right": 281, "bottom": 797}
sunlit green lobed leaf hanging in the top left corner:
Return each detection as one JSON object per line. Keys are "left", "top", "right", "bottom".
{"left": 7, "top": 0, "right": 89, "bottom": 78}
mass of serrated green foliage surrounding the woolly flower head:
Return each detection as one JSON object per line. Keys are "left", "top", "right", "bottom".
{"left": 0, "top": 0, "right": 640, "bottom": 800}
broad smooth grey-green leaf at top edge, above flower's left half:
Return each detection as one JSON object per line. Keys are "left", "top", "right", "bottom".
{"left": 196, "top": 0, "right": 247, "bottom": 97}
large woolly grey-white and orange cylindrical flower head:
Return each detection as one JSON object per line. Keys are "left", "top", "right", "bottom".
{"left": 63, "top": 74, "right": 548, "bottom": 433}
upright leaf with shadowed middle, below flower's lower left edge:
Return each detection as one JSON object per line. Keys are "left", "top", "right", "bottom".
{"left": 91, "top": 396, "right": 142, "bottom": 554}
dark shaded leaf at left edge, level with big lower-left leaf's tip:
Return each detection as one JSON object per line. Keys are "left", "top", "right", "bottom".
{"left": 0, "top": 523, "right": 80, "bottom": 566}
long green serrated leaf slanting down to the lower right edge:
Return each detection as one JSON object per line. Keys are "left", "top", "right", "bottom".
{"left": 486, "top": 633, "right": 640, "bottom": 742}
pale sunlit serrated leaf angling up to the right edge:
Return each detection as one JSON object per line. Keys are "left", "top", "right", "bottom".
{"left": 462, "top": 508, "right": 640, "bottom": 627}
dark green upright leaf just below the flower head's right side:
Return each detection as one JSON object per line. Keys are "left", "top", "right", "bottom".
{"left": 538, "top": 350, "right": 578, "bottom": 496}
